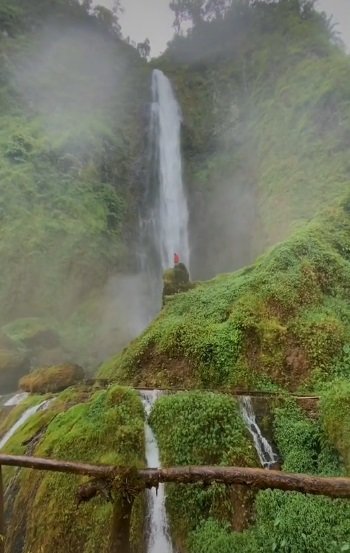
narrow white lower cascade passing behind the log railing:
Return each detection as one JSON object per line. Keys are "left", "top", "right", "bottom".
{"left": 140, "top": 390, "right": 173, "bottom": 553}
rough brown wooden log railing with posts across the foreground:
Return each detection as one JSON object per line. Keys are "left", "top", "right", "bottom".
{"left": 0, "top": 454, "right": 350, "bottom": 553}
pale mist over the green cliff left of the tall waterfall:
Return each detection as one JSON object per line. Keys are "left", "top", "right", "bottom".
{"left": 0, "top": 14, "right": 147, "bottom": 376}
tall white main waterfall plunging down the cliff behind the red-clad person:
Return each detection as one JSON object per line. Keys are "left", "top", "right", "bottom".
{"left": 138, "top": 69, "right": 190, "bottom": 326}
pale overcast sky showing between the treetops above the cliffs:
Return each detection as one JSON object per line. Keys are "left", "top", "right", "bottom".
{"left": 95, "top": 0, "right": 350, "bottom": 56}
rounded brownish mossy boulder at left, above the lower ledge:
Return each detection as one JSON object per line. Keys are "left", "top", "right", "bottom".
{"left": 19, "top": 363, "right": 85, "bottom": 394}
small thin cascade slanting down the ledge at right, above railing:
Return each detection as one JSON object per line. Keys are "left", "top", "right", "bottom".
{"left": 239, "top": 396, "right": 278, "bottom": 468}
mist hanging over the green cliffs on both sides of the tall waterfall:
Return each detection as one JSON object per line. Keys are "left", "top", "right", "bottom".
{"left": 0, "top": 0, "right": 348, "bottom": 382}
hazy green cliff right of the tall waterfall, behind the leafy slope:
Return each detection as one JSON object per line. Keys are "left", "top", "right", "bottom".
{"left": 161, "top": 0, "right": 350, "bottom": 278}
